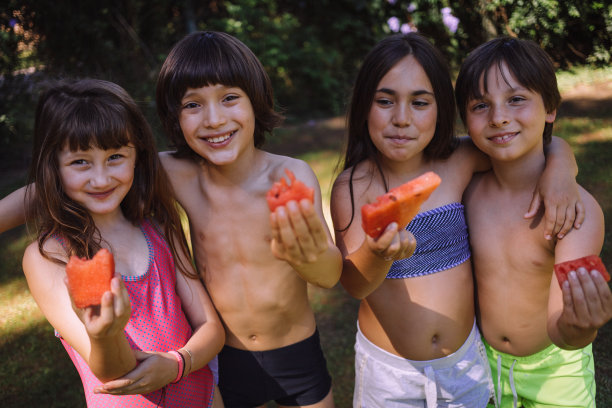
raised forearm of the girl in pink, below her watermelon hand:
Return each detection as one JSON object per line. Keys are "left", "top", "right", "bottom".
{"left": 88, "top": 332, "right": 137, "bottom": 382}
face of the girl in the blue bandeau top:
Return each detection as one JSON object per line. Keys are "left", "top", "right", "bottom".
{"left": 368, "top": 55, "right": 438, "bottom": 165}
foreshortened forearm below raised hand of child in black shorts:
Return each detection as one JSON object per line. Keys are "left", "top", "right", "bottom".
{"left": 292, "top": 244, "right": 342, "bottom": 288}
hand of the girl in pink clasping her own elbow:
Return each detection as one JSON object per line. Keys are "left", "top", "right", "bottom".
{"left": 94, "top": 350, "right": 178, "bottom": 395}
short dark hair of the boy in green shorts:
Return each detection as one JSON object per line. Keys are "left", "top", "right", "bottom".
{"left": 455, "top": 37, "right": 561, "bottom": 144}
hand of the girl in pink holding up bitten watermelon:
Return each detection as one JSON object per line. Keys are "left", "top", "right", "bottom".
{"left": 72, "top": 274, "right": 131, "bottom": 339}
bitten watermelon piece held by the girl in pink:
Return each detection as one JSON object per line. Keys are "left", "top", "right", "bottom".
{"left": 66, "top": 248, "right": 115, "bottom": 308}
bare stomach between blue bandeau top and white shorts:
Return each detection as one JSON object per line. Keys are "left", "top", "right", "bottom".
{"left": 359, "top": 265, "right": 474, "bottom": 361}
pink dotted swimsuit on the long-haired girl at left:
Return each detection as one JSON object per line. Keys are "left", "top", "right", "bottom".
{"left": 60, "top": 221, "right": 214, "bottom": 408}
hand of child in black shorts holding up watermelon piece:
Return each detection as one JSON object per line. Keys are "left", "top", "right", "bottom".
{"left": 270, "top": 199, "right": 329, "bottom": 266}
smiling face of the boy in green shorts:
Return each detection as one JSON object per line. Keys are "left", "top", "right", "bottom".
{"left": 466, "top": 63, "right": 556, "bottom": 160}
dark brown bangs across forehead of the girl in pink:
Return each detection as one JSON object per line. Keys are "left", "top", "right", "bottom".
{"left": 57, "top": 101, "right": 131, "bottom": 151}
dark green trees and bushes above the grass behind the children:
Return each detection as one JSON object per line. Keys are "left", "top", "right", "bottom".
{"left": 0, "top": 0, "right": 612, "bottom": 159}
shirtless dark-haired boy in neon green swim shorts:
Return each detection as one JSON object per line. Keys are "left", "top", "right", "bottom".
{"left": 456, "top": 38, "right": 612, "bottom": 408}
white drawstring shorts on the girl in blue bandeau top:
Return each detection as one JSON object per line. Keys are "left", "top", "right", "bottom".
{"left": 353, "top": 323, "right": 493, "bottom": 408}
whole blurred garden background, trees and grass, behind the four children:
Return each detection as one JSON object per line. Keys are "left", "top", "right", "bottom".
{"left": 0, "top": 0, "right": 612, "bottom": 408}
